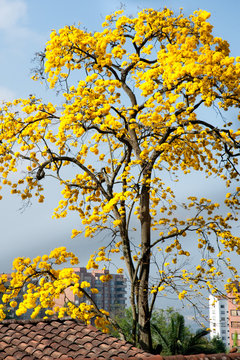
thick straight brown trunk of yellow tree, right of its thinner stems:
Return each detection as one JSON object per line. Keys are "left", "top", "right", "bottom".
{"left": 138, "top": 181, "right": 152, "bottom": 351}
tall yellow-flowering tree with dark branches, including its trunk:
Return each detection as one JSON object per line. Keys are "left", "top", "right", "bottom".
{"left": 0, "top": 8, "right": 240, "bottom": 350}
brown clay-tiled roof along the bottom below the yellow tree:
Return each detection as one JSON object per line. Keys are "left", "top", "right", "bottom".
{"left": 0, "top": 319, "right": 240, "bottom": 360}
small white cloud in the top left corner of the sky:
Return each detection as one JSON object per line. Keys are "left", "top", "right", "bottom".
{"left": 0, "top": 0, "right": 27, "bottom": 31}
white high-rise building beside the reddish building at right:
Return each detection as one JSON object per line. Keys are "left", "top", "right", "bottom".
{"left": 209, "top": 295, "right": 230, "bottom": 348}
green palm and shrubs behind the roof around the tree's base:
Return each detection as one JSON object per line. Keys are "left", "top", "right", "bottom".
{"left": 110, "top": 308, "right": 226, "bottom": 355}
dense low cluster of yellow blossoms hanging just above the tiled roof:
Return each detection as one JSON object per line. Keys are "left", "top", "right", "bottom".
{"left": 0, "top": 247, "right": 110, "bottom": 332}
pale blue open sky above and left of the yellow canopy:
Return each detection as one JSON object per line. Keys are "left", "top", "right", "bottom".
{"left": 0, "top": 0, "right": 240, "bottom": 278}
